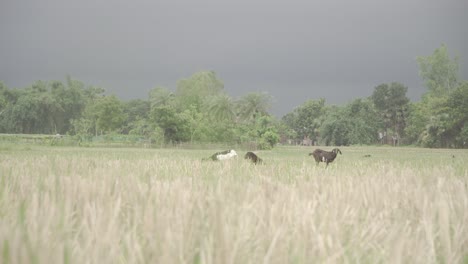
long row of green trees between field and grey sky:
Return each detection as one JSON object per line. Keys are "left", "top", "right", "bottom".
{"left": 0, "top": 45, "right": 468, "bottom": 149}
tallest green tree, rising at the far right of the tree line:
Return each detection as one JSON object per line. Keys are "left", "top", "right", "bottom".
{"left": 411, "top": 45, "right": 465, "bottom": 147}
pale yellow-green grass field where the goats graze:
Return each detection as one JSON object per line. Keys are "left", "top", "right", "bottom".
{"left": 0, "top": 145, "right": 468, "bottom": 264}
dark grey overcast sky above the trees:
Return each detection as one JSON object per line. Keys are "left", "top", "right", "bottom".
{"left": 0, "top": 0, "right": 468, "bottom": 116}
